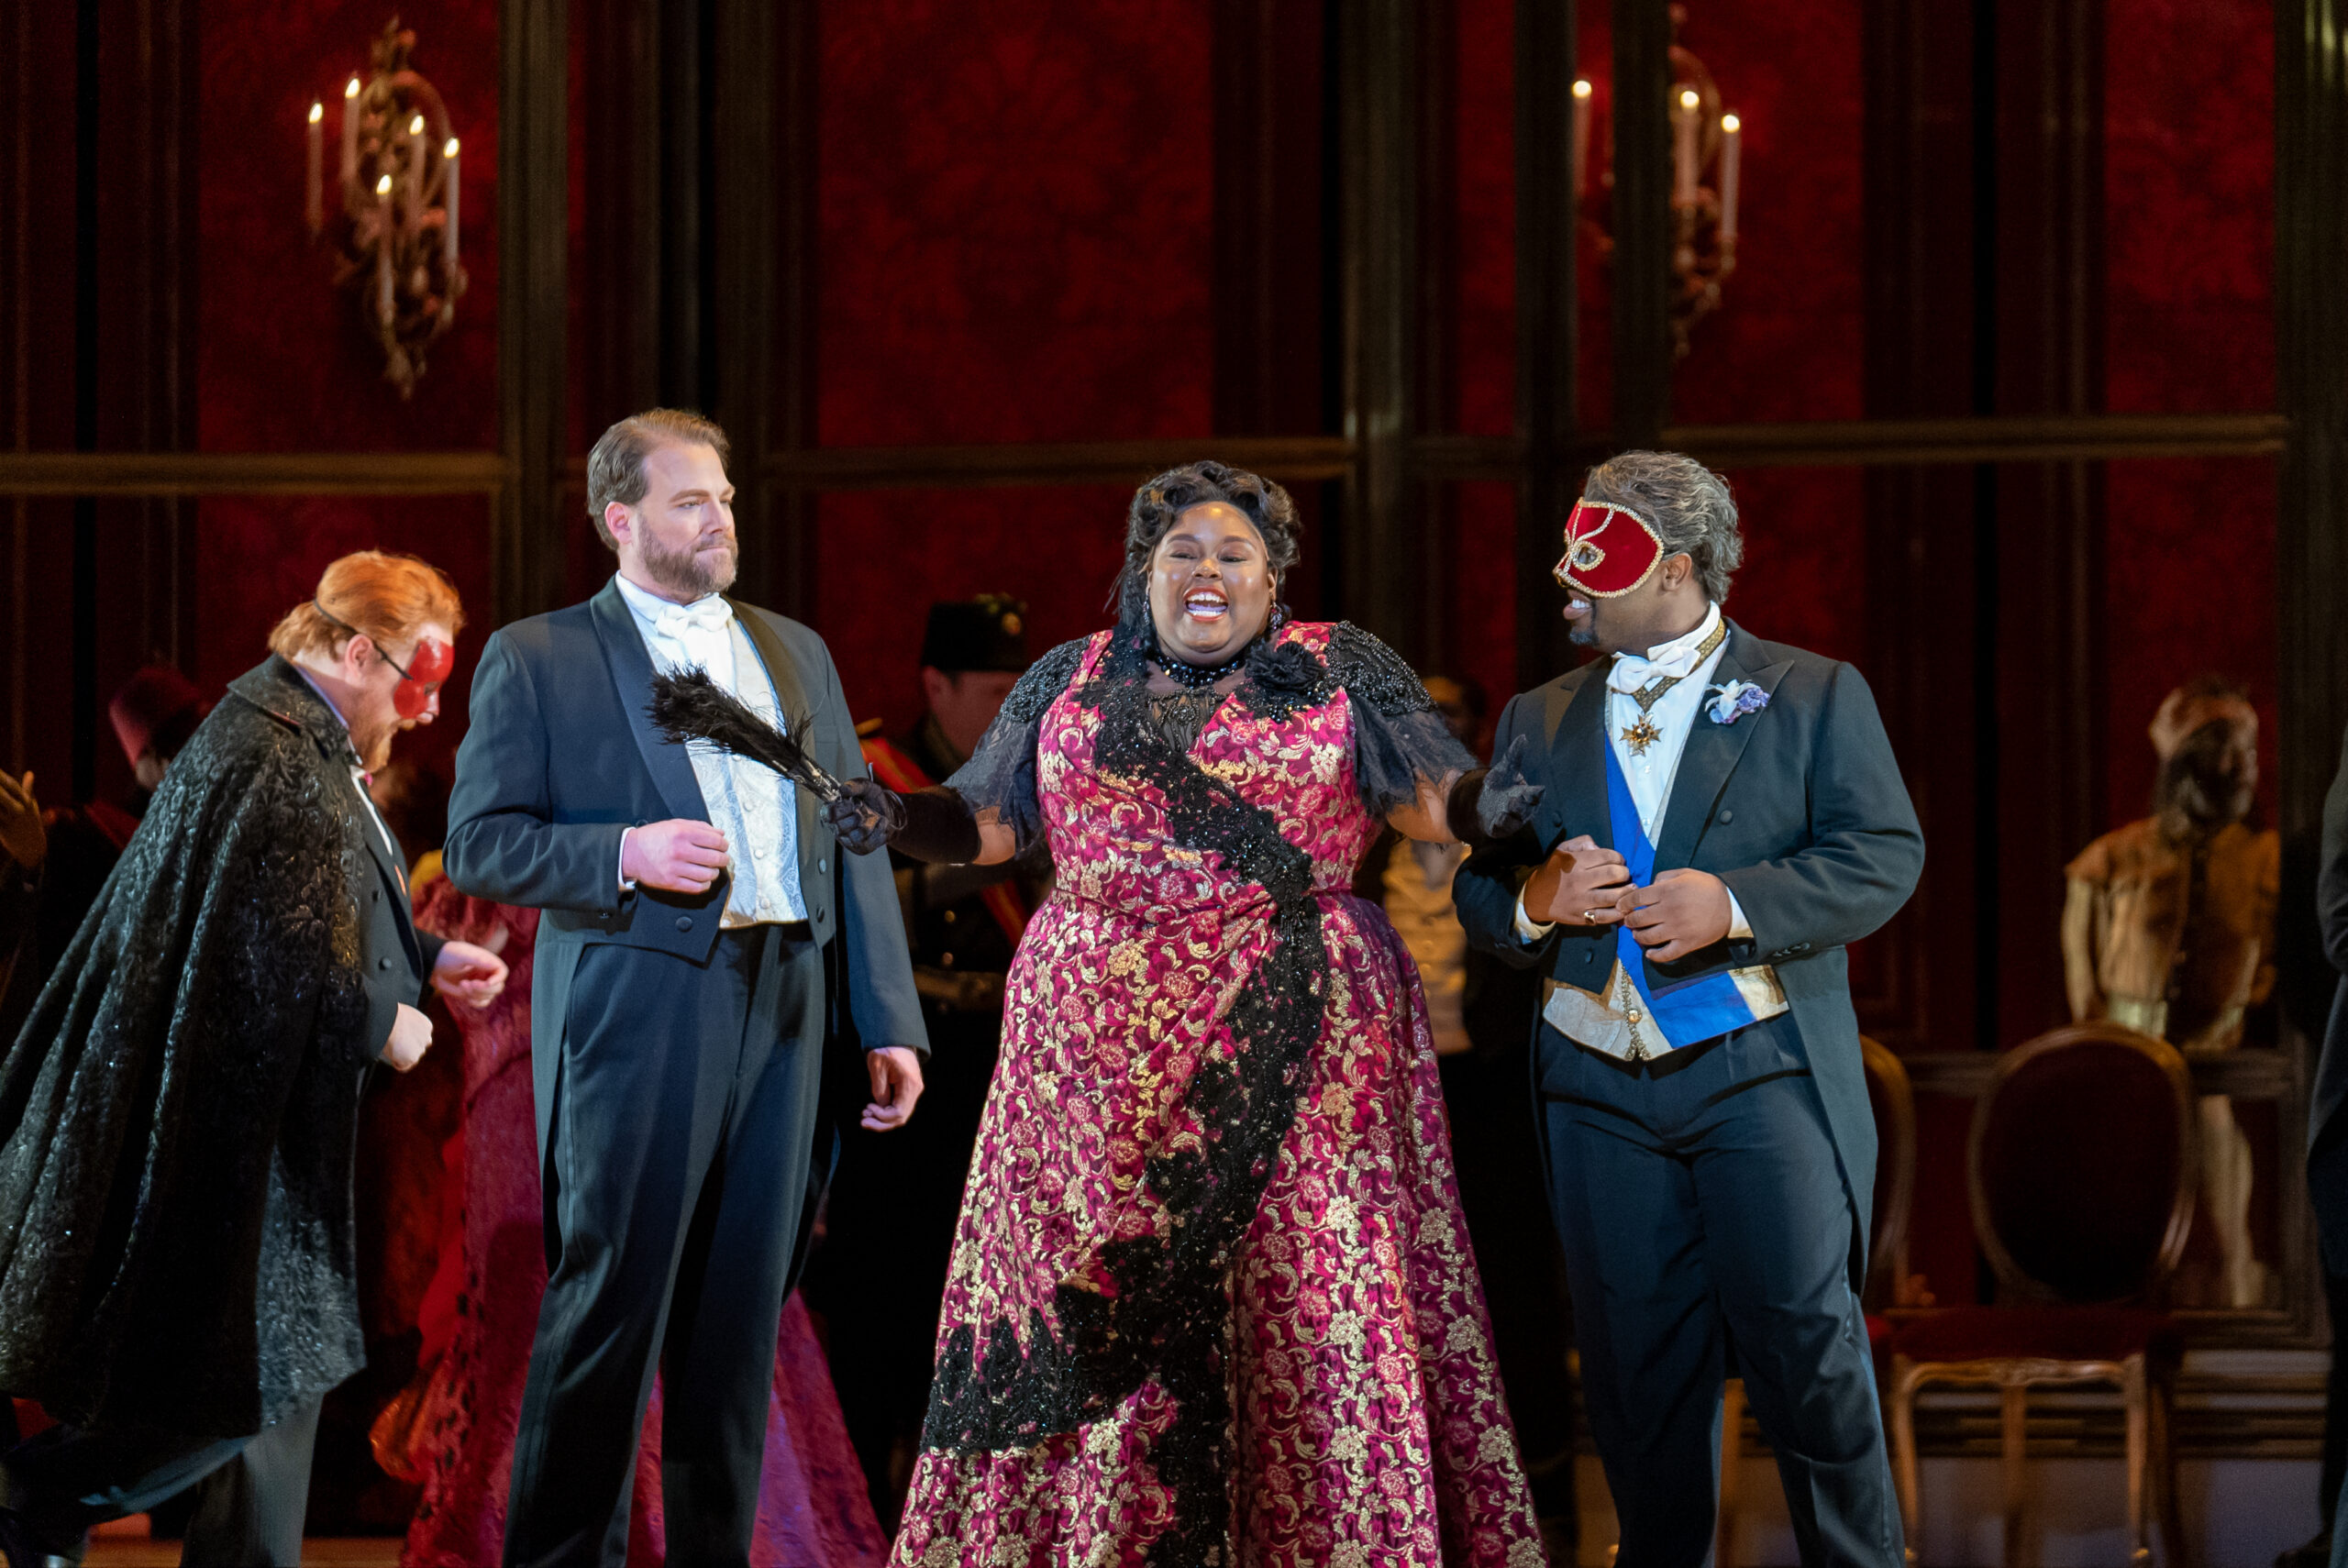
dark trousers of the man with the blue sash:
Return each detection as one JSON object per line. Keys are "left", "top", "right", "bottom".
{"left": 1540, "top": 1016, "right": 1902, "bottom": 1568}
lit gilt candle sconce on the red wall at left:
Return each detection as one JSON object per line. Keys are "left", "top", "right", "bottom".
{"left": 305, "top": 17, "right": 465, "bottom": 399}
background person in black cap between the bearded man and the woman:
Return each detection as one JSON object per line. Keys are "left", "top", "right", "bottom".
{"left": 808, "top": 594, "right": 1049, "bottom": 1528}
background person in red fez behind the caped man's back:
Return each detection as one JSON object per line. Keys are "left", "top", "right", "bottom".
{"left": 0, "top": 664, "right": 211, "bottom": 1044}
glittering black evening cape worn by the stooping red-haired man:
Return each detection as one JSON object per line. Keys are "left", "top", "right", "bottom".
{"left": 0, "top": 659, "right": 381, "bottom": 1437}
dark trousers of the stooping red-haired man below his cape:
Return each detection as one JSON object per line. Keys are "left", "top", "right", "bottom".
{"left": 5, "top": 1399, "right": 322, "bottom": 1568}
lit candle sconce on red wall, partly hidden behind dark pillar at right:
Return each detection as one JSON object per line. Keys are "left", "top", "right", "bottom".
{"left": 1567, "top": 5, "right": 1744, "bottom": 359}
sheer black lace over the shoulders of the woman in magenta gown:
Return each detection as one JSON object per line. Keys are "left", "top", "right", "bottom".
{"left": 947, "top": 617, "right": 1477, "bottom": 852}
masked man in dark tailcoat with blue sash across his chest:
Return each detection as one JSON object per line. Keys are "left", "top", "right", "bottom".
{"left": 1454, "top": 453, "right": 1923, "bottom": 1568}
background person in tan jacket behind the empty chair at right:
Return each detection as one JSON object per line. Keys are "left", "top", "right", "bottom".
{"left": 2062, "top": 676, "right": 2282, "bottom": 1308}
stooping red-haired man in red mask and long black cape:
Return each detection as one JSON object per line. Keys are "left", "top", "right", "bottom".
{"left": 0, "top": 552, "right": 504, "bottom": 1568}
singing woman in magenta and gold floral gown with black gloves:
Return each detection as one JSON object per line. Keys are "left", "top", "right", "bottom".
{"left": 834, "top": 462, "right": 1545, "bottom": 1568}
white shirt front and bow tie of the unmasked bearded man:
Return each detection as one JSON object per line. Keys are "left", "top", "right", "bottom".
{"left": 613, "top": 575, "right": 808, "bottom": 930}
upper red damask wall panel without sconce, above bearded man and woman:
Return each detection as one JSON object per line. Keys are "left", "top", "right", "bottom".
{"left": 817, "top": 0, "right": 1214, "bottom": 453}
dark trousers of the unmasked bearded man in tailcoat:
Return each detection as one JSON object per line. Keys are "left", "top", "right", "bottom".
{"left": 504, "top": 925, "right": 825, "bottom": 1568}
